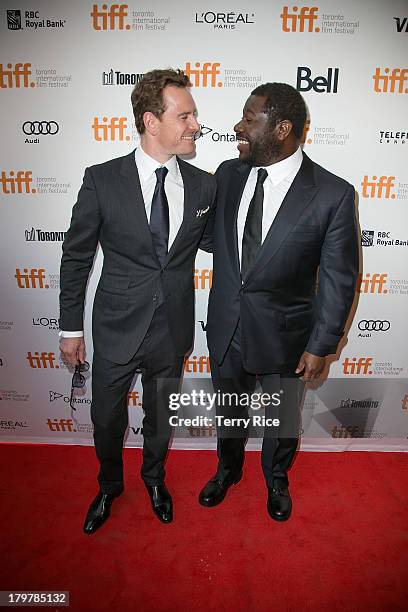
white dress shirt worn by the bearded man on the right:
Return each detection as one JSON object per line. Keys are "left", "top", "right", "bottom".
{"left": 237, "top": 147, "right": 303, "bottom": 263}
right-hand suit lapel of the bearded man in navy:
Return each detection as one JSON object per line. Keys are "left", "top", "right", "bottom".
{"left": 245, "top": 154, "right": 319, "bottom": 282}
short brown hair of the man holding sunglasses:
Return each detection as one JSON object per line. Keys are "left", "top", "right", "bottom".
{"left": 130, "top": 68, "right": 190, "bottom": 134}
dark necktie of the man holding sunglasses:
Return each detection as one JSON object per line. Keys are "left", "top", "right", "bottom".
{"left": 150, "top": 166, "right": 169, "bottom": 265}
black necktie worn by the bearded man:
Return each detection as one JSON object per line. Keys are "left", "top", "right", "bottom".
{"left": 241, "top": 168, "right": 268, "bottom": 278}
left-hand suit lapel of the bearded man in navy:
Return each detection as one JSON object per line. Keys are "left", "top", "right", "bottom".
{"left": 225, "top": 164, "right": 251, "bottom": 274}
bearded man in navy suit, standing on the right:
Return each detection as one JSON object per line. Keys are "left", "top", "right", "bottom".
{"left": 199, "top": 83, "right": 358, "bottom": 521}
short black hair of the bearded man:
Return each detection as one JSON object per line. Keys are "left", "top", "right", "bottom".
{"left": 251, "top": 83, "right": 307, "bottom": 138}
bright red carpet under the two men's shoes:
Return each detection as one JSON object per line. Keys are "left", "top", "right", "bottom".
{"left": 0, "top": 444, "right": 408, "bottom": 612}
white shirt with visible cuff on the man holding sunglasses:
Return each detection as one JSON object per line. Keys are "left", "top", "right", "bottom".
{"left": 59, "top": 146, "right": 184, "bottom": 338}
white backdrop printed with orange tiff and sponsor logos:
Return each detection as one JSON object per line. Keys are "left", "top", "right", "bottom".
{"left": 0, "top": 0, "right": 408, "bottom": 450}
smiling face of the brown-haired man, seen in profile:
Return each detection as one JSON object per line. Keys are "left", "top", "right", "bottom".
{"left": 141, "top": 85, "right": 200, "bottom": 162}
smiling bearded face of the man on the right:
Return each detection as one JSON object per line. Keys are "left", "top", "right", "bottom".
{"left": 234, "top": 96, "right": 282, "bottom": 166}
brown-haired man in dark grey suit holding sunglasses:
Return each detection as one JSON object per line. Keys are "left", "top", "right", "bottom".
{"left": 60, "top": 70, "right": 216, "bottom": 534}
